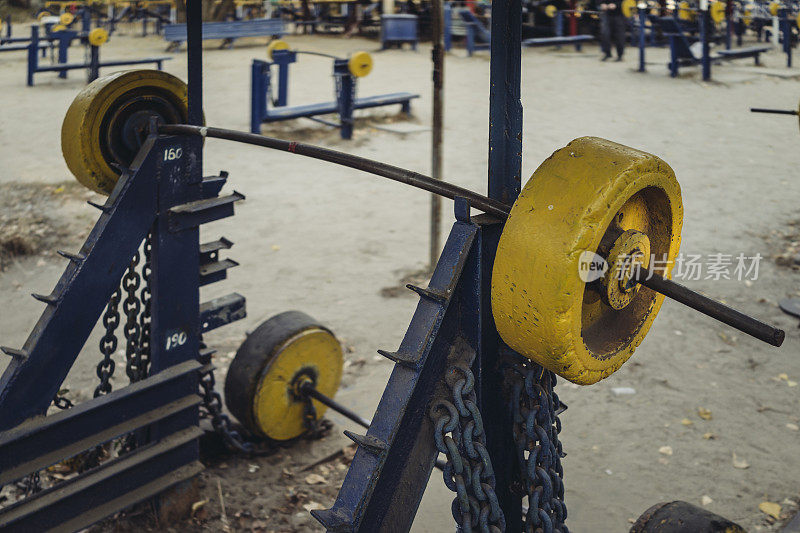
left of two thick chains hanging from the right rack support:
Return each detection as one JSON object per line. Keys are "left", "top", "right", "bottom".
{"left": 430, "top": 362, "right": 506, "bottom": 533}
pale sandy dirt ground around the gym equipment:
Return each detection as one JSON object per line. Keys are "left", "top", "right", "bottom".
{"left": 0, "top": 18, "right": 800, "bottom": 533}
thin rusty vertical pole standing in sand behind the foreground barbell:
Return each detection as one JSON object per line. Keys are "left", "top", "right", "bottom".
{"left": 428, "top": 0, "right": 444, "bottom": 272}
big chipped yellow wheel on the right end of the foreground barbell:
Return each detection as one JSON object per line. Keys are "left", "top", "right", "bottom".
{"left": 491, "top": 137, "right": 683, "bottom": 385}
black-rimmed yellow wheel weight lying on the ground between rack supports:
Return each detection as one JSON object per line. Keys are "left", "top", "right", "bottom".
{"left": 225, "top": 311, "right": 344, "bottom": 441}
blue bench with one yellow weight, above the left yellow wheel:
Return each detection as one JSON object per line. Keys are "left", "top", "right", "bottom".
{"left": 27, "top": 26, "right": 172, "bottom": 87}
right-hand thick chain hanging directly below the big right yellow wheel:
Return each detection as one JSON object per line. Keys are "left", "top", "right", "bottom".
{"left": 506, "top": 362, "right": 569, "bottom": 533}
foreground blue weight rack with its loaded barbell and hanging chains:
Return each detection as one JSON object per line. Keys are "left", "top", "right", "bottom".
{"left": 0, "top": 0, "right": 784, "bottom": 533}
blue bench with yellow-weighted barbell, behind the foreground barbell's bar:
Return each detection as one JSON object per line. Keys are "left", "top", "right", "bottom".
{"left": 250, "top": 40, "right": 419, "bottom": 139}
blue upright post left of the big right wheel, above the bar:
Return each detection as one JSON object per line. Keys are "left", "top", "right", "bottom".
{"left": 489, "top": 0, "right": 522, "bottom": 205}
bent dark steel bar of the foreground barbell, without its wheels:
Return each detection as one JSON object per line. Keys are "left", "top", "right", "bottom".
{"left": 159, "top": 124, "right": 786, "bottom": 347}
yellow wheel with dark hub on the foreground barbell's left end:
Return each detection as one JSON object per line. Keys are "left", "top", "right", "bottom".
{"left": 61, "top": 70, "right": 188, "bottom": 194}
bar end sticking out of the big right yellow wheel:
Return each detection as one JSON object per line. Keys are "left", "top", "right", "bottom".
{"left": 636, "top": 267, "right": 786, "bottom": 346}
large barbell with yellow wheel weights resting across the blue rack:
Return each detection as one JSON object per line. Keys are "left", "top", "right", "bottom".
{"left": 61, "top": 70, "right": 785, "bottom": 385}
